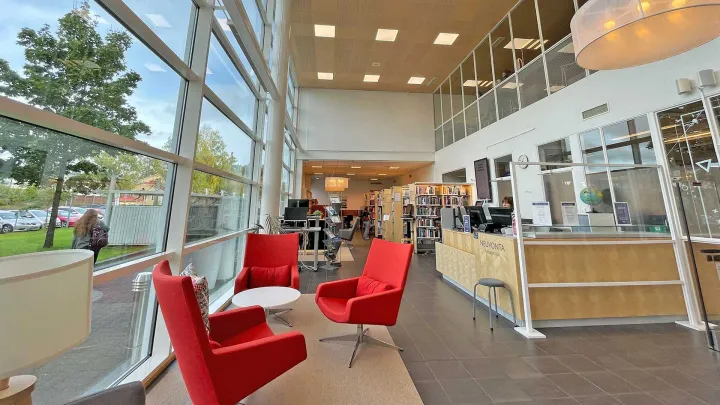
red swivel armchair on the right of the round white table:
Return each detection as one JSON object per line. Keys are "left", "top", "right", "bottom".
{"left": 315, "top": 239, "right": 413, "bottom": 367}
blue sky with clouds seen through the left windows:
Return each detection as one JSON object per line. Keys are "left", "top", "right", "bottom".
{"left": 0, "top": 0, "right": 262, "bottom": 170}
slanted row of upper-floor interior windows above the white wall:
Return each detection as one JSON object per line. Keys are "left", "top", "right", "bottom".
{"left": 433, "top": 0, "right": 586, "bottom": 151}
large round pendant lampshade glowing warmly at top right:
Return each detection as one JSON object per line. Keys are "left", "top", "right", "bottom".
{"left": 570, "top": 0, "right": 720, "bottom": 70}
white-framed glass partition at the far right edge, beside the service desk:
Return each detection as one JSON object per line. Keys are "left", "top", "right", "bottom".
{"left": 657, "top": 96, "right": 720, "bottom": 350}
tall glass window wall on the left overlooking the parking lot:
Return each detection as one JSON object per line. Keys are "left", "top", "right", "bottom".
{"left": 0, "top": 0, "right": 286, "bottom": 405}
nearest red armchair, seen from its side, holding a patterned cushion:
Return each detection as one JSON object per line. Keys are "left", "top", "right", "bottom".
{"left": 153, "top": 260, "right": 307, "bottom": 405}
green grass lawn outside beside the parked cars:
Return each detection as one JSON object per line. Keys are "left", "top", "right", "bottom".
{"left": 0, "top": 228, "right": 146, "bottom": 262}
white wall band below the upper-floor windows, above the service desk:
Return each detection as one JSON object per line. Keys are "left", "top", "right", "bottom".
{"left": 434, "top": 39, "right": 720, "bottom": 216}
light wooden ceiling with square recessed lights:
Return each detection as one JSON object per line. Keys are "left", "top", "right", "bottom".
{"left": 291, "top": 0, "right": 517, "bottom": 92}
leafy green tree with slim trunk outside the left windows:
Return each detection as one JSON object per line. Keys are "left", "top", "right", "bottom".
{"left": 0, "top": 2, "right": 150, "bottom": 248}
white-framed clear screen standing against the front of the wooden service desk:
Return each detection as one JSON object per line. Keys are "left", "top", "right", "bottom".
{"left": 505, "top": 162, "right": 689, "bottom": 336}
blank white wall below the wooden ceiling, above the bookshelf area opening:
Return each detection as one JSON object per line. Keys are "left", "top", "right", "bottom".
{"left": 298, "top": 88, "right": 435, "bottom": 162}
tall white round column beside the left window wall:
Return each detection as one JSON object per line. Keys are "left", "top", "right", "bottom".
{"left": 260, "top": 0, "right": 292, "bottom": 224}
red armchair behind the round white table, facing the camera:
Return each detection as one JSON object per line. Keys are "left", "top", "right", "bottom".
{"left": 235, "top": 233, "right": 300, "bottom": 326}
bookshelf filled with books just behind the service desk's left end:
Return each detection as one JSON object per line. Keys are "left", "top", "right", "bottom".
{"left": 409, "top": 183, "right": 472, "bottom": 253}
